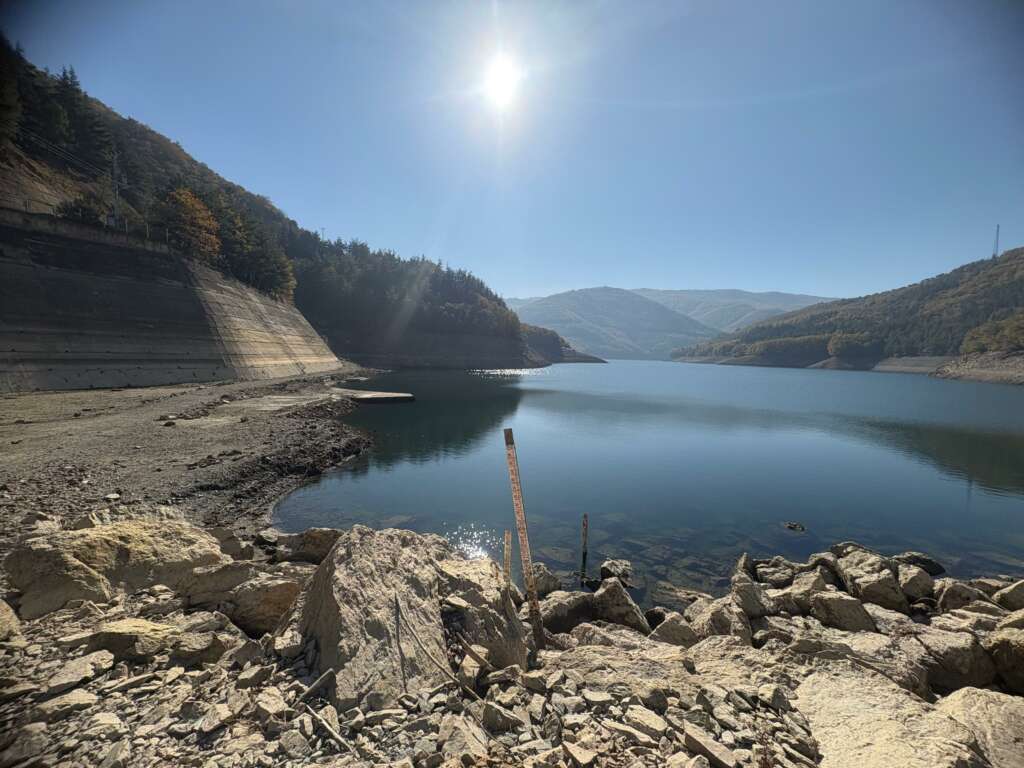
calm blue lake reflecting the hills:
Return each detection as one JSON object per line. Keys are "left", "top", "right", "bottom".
{"left": 274, "top": 360, "right": 1024, "bottom": 599}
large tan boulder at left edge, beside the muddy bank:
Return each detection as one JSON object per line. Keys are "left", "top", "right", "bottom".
{"left": 4, "top": 519, "right": 229, "bottom": 618}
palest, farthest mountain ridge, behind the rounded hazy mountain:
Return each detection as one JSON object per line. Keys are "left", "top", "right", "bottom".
{"left": 630, "top": 288, "right": 835, "bottom": 331}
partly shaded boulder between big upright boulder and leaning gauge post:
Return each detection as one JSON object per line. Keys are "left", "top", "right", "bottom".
{"left": 438, "top": 557, "right": 527, "bottom": 669}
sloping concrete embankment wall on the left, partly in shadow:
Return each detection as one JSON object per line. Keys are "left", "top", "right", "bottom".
{"left": 0, "top": 209, "right": 342, "bottom": 392}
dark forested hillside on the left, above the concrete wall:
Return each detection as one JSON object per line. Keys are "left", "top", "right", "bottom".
{"left": 0, "top": 40, "right": 577, "bottom": 366}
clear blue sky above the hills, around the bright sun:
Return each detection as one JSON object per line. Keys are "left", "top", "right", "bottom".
{"left": 0, "top": 0, "right": 1024, "bottom": 296}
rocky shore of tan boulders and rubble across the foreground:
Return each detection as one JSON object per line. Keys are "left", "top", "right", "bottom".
{"left": 0, "top": 505, "right": 1024, "bottom": 768}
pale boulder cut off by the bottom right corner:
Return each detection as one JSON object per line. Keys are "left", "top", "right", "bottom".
{"left": 935, "top": 688, "right": 1024, "bottom": 768}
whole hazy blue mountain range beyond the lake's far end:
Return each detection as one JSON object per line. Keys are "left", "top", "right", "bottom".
{"left": 506, "top": 287, "right": 829, "bottom": 359}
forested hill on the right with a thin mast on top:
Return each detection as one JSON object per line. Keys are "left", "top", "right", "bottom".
{"left": 674, "top": 248, "right": 1024, "bottom": 366}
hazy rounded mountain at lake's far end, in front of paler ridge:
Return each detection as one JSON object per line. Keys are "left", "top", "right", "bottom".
{"left": 507, "top": 288, "right": 718, "bottom": 359}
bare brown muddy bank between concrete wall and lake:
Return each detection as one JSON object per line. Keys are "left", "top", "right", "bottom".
{"left": 0, "top": 364, "right": 367, "bottom": 581}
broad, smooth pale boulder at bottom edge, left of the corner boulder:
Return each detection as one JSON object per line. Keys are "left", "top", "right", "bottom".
{"left": 795, "top": 665, "right": 987, "bottom": 768}
